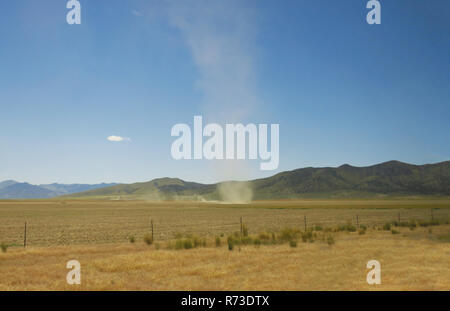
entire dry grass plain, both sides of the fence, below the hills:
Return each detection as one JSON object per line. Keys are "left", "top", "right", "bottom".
{"left": 0, "top": 200, "right": 450, "bottom": 290}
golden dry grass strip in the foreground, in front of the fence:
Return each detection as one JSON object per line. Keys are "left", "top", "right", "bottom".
{"left": 0, "top": 225, "right": 450, "bottom": 290}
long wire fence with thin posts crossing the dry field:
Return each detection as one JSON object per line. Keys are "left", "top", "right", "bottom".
{"left": 0, "top": 208, "right": 450, "bottom": 246}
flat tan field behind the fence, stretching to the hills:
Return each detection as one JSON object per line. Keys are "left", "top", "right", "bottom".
{"left": 0, "top": 199, "right": 450, "bottom": 246}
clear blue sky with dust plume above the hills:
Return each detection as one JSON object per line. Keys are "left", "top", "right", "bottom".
{"left": 0, "top": 0, "right": 450, "bottom": 184}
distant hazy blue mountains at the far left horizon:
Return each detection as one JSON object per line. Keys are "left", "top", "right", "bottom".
{"left": 0, "top": 180, "right": 117, "bottom": 199}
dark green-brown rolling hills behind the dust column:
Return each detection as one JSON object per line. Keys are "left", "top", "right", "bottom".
{"left": 70, "top": 161, "right": 450, "bottom": 201}
